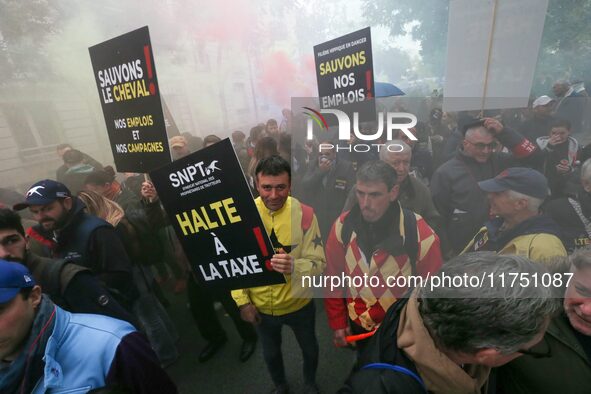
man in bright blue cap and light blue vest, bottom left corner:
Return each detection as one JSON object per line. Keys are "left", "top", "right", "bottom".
{"left": 0, "top": 260, "right": 177, "bottom": 394}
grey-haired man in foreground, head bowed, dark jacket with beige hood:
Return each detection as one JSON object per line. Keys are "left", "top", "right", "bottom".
{"left": 341, "top": 252, "right": 565, "bottom": 394}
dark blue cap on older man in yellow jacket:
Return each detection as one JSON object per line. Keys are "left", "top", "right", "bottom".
{"left": 478, "top": 167, "right": 549, "bottom": 200}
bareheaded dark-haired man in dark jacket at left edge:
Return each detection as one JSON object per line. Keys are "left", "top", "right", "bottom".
{"left": 0, "top": 208, "right": 136, "bottom": 325}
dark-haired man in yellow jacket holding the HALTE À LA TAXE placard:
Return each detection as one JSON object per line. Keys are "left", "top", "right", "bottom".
{"left": 232, "top": 156, "right": 326, "bottom": 393}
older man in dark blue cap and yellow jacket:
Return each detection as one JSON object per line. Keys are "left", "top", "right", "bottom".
{"left": 462, "top": 167, "right": 566, "bottom": 262}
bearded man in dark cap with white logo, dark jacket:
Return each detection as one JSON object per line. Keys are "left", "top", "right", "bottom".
{"left": 14, "top": 179, "right": 137, "bottom": 309}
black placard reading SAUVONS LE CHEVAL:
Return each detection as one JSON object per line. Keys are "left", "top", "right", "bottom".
{"left": 88, "top": 26, "right": 171, "bottom": 173}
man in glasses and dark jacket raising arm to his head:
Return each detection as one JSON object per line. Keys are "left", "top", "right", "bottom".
{"left": 429, "top": 118, "right": 539, "bottom": 254}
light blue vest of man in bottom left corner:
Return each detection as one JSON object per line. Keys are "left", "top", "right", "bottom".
{"left": 33, "top": 306, "right": 135, "bottom": 394}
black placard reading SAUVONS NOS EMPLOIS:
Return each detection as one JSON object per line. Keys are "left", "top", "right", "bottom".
{"left": 314, "top": 27, "right": 376, "bottom": 123}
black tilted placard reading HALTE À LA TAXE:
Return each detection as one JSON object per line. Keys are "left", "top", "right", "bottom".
{"left": 150, "top": 139, "right": 285, "bottom": 289}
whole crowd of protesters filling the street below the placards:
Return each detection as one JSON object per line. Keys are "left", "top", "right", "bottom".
{"left": 0, "top": 81, "right": 591, "bottom": 394}
